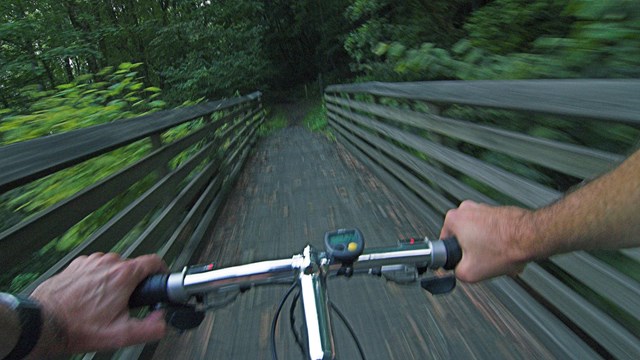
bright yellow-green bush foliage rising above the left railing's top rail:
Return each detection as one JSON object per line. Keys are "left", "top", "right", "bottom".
{"left": 0, "top": 63, "right": 165, "bottom": 145}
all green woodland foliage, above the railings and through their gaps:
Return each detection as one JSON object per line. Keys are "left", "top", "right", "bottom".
{"left": 0, "top": 0, "right": 640, "bottom": 320}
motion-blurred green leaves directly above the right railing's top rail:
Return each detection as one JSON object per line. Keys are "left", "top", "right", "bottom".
{"left": 358, "top": 0, "right": 640, "bottom": 81}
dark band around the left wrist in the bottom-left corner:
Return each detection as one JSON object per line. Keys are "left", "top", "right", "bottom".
{"left": 3, "top": 295, "right": 42, "bottom": 360}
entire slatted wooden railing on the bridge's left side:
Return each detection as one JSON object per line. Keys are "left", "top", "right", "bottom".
{"left": 0, "top": 92, "right": 264, "bottom": 293}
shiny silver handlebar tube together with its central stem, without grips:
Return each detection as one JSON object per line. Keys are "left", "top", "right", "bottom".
{"left": 167, "top": 240, "right": 446, "bottom": 360}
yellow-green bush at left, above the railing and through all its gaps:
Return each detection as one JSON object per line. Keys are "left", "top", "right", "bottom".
{"left": 0, "top": 63, "right": 208, "bottom": 291}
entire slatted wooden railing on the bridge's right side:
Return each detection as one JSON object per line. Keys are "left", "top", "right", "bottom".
{"left": 325, "top": 80, "right": 640, "bottom": 359}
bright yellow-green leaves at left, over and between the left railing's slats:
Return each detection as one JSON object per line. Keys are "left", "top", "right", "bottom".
{"left": 0, "top": 63, "right": 163, "bottom": 250}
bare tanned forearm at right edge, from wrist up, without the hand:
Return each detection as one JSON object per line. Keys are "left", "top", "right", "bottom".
{"left": 527, "top": 151, "right": 640, "bottom": 260}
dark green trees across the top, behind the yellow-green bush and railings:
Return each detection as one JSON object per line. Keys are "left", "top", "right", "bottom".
{"left": 0, "top": 0, "right": 640, "bottom": 109}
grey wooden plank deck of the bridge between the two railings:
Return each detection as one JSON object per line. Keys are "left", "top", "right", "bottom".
{"left": 154, "top": 122, "right": 551, "bottom": 359}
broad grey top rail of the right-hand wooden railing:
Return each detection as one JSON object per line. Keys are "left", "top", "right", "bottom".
{"left": 326, "top": 80, "right": 640, "bottom": 124}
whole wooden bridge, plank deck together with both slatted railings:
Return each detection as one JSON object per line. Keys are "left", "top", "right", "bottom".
{"left": 0, "top": 80, "right": 640, "bottom": 359}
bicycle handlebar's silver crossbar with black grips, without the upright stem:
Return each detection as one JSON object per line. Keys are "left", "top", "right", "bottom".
{"left": 129, "top": 238, "right": 462, "bottom": 308}
